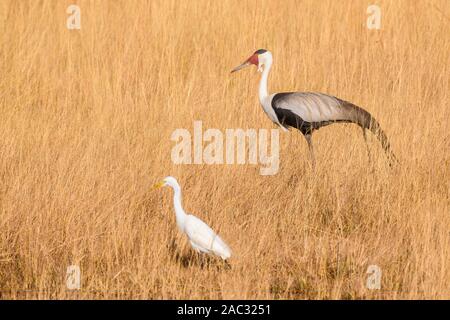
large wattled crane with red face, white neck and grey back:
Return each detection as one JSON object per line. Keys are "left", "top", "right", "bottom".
{"left": 231, "top": 49, "right": 396, "bottom": 166}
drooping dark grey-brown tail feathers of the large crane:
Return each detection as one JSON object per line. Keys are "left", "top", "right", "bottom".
{"left": 343, "top": 102, "right": 399, "bottom": 167}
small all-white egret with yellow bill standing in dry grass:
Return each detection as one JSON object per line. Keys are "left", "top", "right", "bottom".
{"left": 155, "top": 177, "right": 231, "bottom": 260}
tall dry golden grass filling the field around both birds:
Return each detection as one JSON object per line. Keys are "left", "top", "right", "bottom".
{"left": 0, "top": 0, "right": 450, "bottom": 299}
